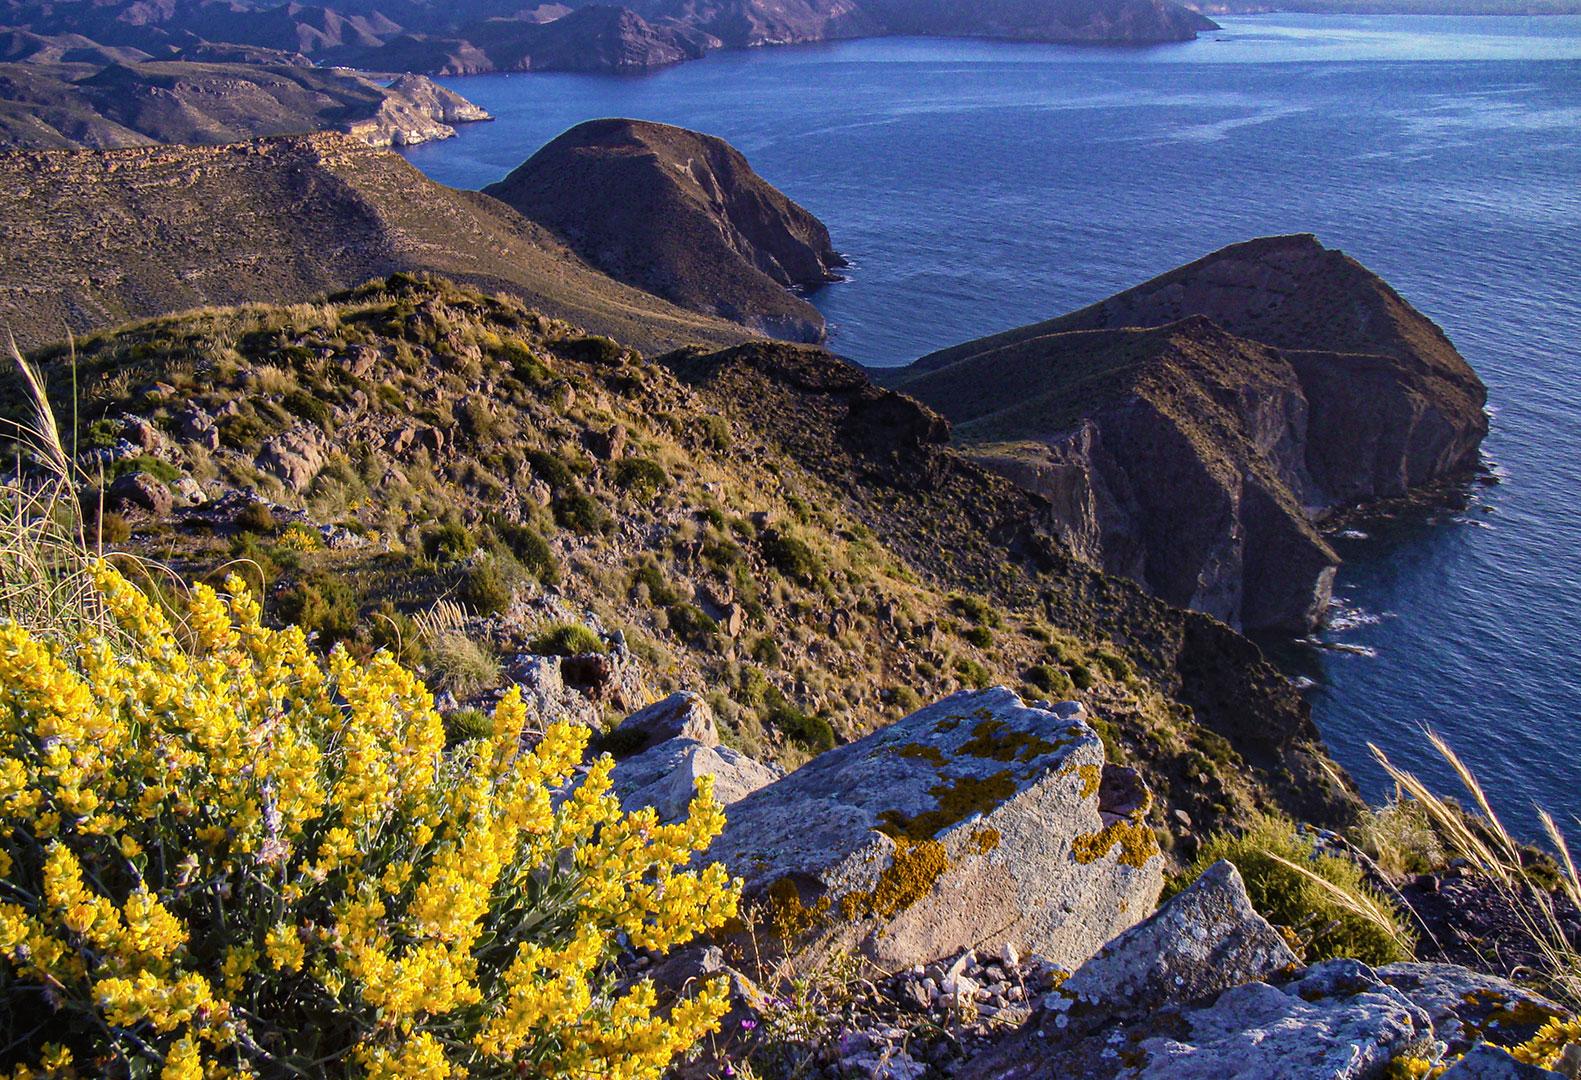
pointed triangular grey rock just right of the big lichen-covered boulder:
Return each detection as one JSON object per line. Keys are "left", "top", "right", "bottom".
{"left": 1056, "top": 859, "right": 1300, "bottom": 1012}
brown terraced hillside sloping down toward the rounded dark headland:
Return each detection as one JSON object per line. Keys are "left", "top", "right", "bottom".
{"left": 0, "top": 134, "right": 746, "bottom": 348}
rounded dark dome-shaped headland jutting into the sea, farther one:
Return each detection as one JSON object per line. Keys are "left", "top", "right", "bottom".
{"left": 485, "top": 120, "right": 844, "bottom": 342}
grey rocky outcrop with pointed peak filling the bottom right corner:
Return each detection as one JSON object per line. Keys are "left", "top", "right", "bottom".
{"left": 958, "top": 862, "right": 1565, "bottom": 1080}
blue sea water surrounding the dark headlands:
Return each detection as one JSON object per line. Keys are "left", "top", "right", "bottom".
{"left": 398, "top": 14, "right": 1581, "bottom": 835}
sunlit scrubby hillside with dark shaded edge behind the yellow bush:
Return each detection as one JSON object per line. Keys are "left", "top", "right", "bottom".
{"left": 9, "top": 278, "right": 1353, "bottom": 847}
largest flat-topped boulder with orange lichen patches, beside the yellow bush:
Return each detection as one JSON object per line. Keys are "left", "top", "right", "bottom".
{"left": 707, "top": 688, "right": 1162, "bottom": 968}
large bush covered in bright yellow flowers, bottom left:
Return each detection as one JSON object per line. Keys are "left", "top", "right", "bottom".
{"left": 0, "top": 563, "right": 738, "bottom": 1080}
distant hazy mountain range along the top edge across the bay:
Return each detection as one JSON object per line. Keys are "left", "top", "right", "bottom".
{"left": 0, "top": 0, "right": 1214, "bottom": 74}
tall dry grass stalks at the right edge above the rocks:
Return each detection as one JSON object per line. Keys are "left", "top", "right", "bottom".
{"left": 1368, "top": 731, "right": 1581, "bottom": 1009}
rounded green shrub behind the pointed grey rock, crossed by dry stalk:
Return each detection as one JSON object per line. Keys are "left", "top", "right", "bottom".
{"left": 1179, "top": 814, "right": 1413, "bottom": 965}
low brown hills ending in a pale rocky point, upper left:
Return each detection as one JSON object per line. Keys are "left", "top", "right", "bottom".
{"left": 0, "top": 59, "right": 489, "bottom": 149}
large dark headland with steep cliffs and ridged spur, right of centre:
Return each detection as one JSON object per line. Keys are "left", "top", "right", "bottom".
{"left": 892, "top": 236, "right": 1486, "bottom": 629}
